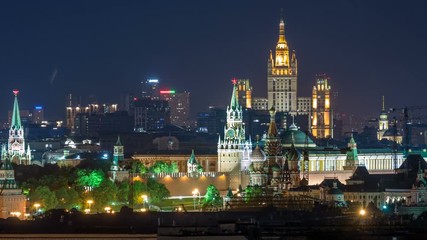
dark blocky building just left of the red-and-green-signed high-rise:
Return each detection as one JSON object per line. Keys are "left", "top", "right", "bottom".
{"left": 134, "top": 98, "right": 170, "bottom": 132}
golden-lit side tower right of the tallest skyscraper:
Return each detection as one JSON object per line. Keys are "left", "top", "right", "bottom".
{"left": 311, "top": 74, "right": 334, "bottom": 138}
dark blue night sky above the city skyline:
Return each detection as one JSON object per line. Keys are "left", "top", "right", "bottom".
{"left": 0, "top": 0, "right": 427, "bottom": 120}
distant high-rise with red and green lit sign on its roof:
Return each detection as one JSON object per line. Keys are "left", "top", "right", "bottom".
{"left": 160, "top": 90, "right": 191, "bottom": 128}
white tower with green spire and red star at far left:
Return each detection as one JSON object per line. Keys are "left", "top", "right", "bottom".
{"left": 2, "top": 90, "right": 31, "bottom": 165}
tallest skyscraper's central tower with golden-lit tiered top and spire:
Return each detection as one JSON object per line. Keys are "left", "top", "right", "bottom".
{"left": 267, "top": 15, "right": 298, "bottom": 115}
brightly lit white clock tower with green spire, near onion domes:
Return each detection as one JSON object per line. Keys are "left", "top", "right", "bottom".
{"left": 218, "top": 80, "right": 252, "bottom": 172}
